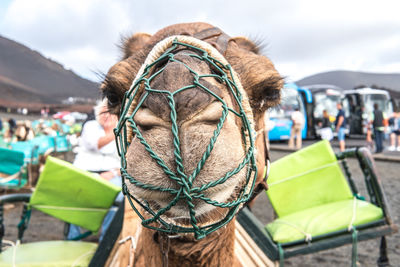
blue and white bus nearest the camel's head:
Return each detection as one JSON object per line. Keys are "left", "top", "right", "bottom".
{"left": 267, "top": 83, "right": 307, "bottom": 141}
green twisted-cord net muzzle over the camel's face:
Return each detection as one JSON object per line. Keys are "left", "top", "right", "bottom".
{"left": 114, "top": 40, "right": 257, "bottom": 239}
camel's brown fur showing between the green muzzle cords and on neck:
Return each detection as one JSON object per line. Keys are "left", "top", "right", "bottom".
{"left": 101, "top": 23, "right": 283, "bottom": 266}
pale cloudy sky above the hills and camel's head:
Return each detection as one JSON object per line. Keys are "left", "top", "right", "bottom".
{"left": 0, "top": 0, "right": 400, "bottom": 82}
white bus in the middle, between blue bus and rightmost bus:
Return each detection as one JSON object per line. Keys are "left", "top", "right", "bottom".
{"left": 302, "top": 84, "right": 348, "bottom": 138}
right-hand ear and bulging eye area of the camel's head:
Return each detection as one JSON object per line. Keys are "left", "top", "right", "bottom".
{"left": 225, "top": 37, "right": 284, "bottom": 115}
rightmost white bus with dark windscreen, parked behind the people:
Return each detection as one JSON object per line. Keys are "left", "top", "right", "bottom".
{"left": 343, "top": 87, "right": 393, "bottom": 134}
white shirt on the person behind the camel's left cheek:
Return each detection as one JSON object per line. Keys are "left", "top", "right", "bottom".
{"left": 74, "top": 120, "right": 121, "bottom": 171}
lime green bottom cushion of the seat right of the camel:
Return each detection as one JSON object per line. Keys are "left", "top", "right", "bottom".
{"left": 265, "top": 199, "right": 383, "bottom": 243}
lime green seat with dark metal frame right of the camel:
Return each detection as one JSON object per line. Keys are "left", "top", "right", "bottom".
{"left": 238, "top": 141, "right": 397, "bottom": 266}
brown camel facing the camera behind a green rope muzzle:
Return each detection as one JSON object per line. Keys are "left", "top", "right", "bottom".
{"left": 101, "top": 23, "right": 283, "bottom": 266}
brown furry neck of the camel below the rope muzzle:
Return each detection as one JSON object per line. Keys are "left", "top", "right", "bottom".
{"left": 134, "top": 220, "right": 240, "bottom": 267}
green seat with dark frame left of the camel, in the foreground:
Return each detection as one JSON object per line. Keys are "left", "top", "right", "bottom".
{"left": 0, "top": 156, "right": 123, "bottom": 267}
